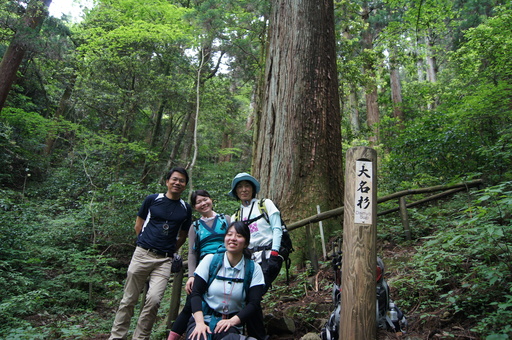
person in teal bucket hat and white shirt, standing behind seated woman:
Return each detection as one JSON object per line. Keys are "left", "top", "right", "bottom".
{"left": 228, "top": 172, "right": 283, "bottom": 292}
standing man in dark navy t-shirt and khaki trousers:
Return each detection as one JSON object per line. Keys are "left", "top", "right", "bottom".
{"left": 109, "top": 167, "right": 192, "bottom": 340}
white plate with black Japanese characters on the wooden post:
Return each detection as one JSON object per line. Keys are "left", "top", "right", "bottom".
{"left": 354, "top": 161, "right": 374, "bottom": 224}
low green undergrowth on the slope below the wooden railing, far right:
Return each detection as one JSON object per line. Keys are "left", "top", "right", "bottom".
{"left": 393, "top": 182, "right": 512, "bottom": 336}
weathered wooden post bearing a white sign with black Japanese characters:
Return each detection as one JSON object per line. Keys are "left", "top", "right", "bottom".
{"left": 340, "top": 147, "right": 377, "bottom": 340}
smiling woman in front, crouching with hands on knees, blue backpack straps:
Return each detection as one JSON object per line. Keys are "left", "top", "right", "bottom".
{"left": 187, "top": 222, "right": 265, "bottom": 340}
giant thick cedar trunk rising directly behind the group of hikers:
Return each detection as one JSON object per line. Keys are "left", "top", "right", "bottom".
{"left": 253, "top": 0, "right": 343, "bottom": 254}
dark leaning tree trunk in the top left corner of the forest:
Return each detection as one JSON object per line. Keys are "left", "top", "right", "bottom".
{"left": 0, "top": 0, "right": 52, "bottom": 111}
